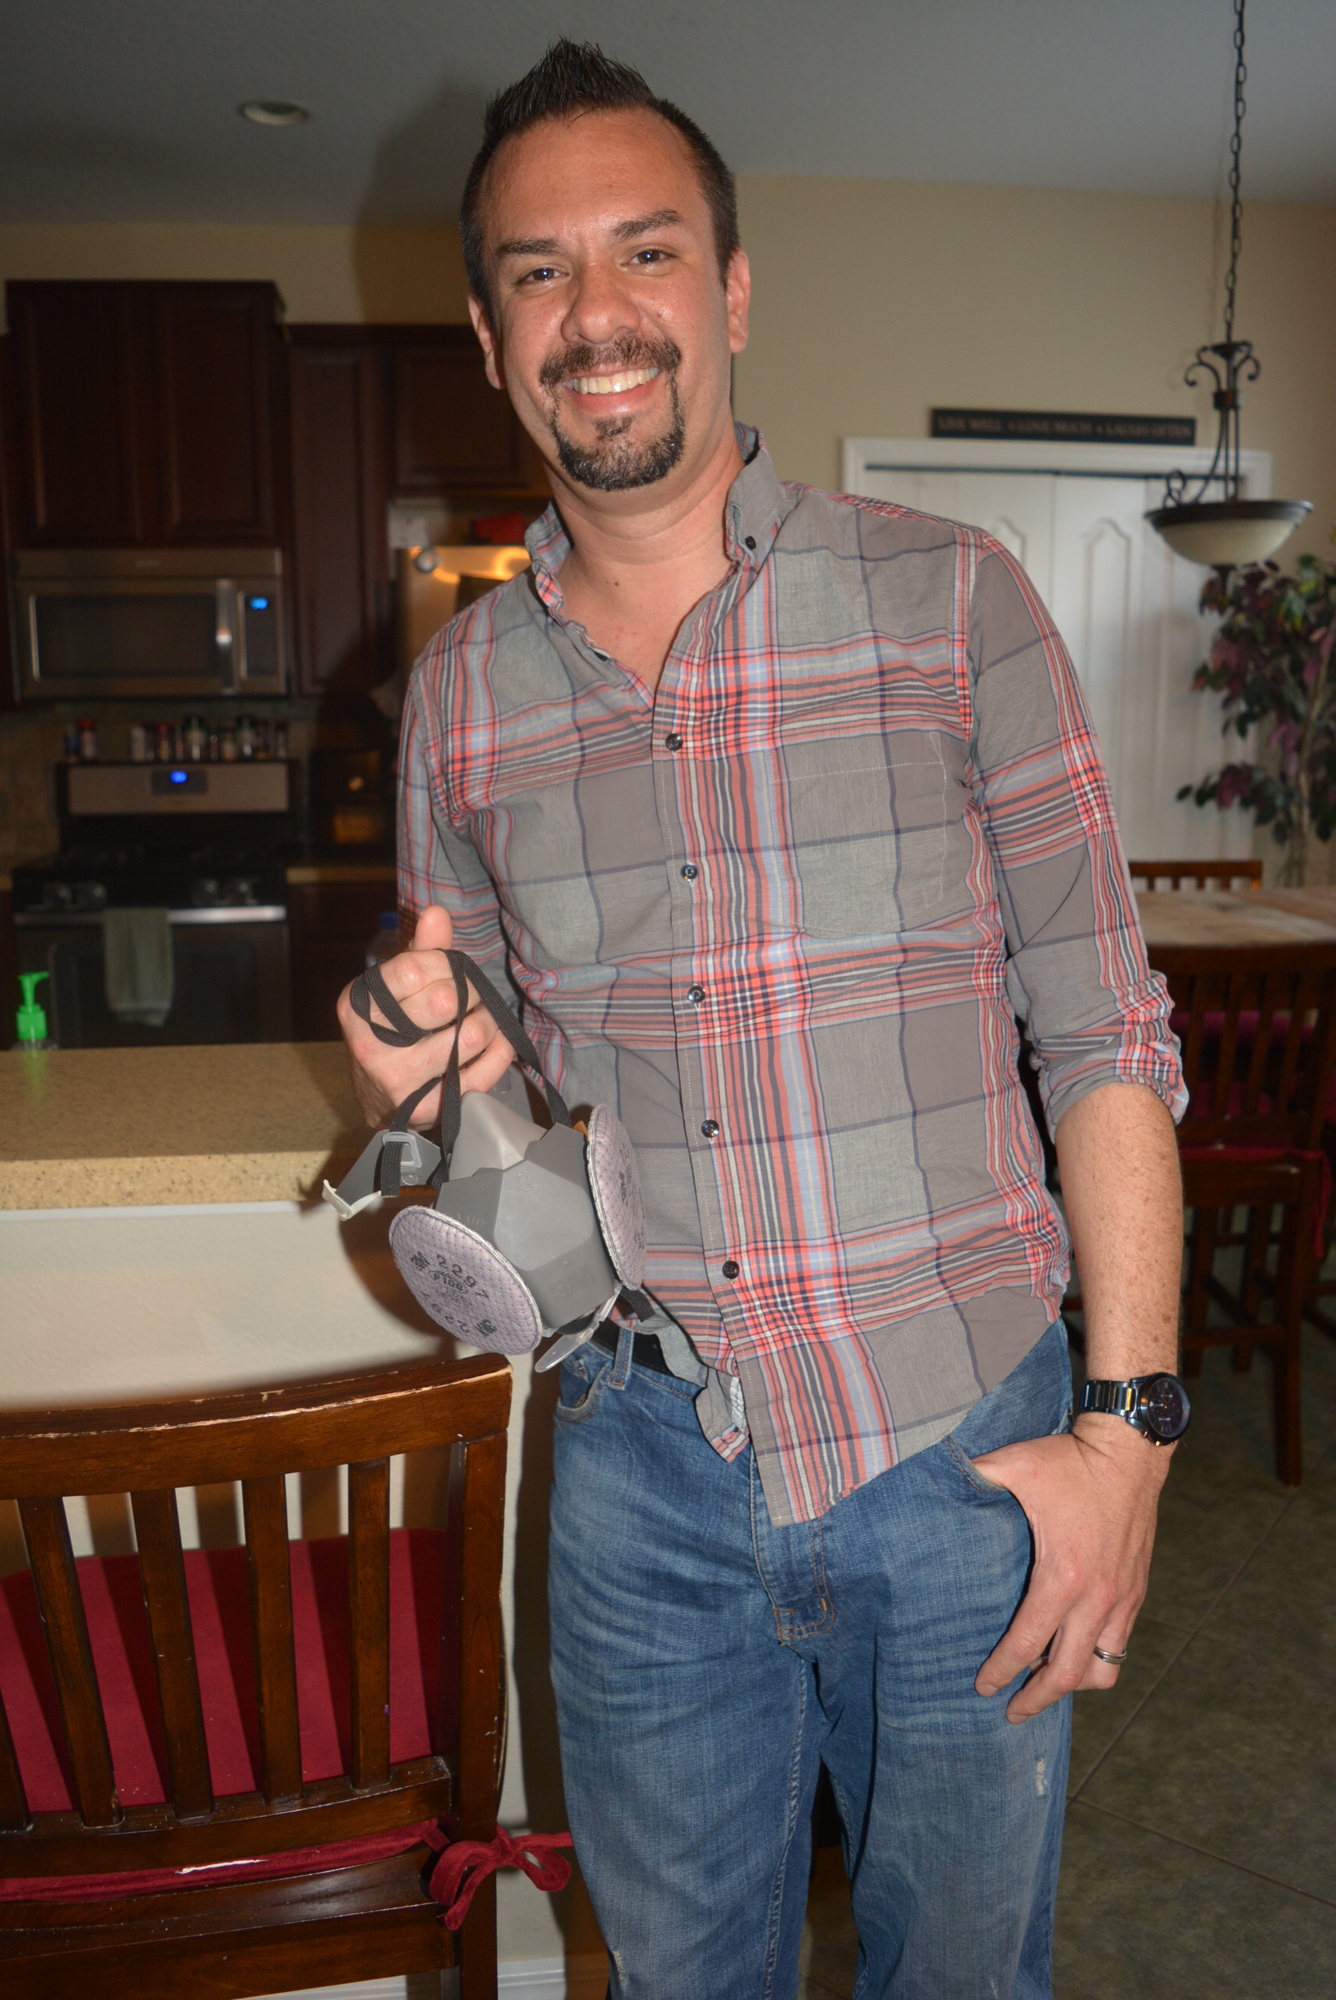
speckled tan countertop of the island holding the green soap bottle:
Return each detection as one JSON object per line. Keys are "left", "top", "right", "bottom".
{"left": 0, "top": 1042, "right": 366, "bottom": 1208}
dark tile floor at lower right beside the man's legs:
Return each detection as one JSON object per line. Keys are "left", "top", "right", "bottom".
{"left": 802, "top": 1334, "right": 1336, "bottom": 2000}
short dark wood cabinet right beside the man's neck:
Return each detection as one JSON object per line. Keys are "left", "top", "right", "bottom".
{"left": 386, "top": 326, "right": 542, "bottom": 494}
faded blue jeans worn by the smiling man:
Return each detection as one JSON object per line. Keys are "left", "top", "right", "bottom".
{"left": 550, "top": 1326, "right": 1072, "bottom": 2000}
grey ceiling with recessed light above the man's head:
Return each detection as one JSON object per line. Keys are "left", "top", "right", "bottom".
{"left": 0, "top": 0, "right": 1336, "bottom": 222}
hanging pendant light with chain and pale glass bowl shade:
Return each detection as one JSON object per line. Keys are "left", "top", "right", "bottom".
{"left": 1146, "top": 0, "right": 1312, "bottom": 574}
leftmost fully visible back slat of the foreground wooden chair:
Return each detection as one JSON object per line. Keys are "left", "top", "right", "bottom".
{"left": 18, "top": 1498, "right": 120, "bottom": 1826}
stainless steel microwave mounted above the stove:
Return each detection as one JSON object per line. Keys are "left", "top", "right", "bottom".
{"left": 14, "top": 548, "right": 288, "bottom": 702}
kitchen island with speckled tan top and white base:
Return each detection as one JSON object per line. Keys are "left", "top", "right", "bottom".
{"left": 0, "top": 1042, "right": 606, "bottom": 2000}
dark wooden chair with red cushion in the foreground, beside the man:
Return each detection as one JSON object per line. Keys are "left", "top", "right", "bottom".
{"left": 0, "top": 1358, "right": 510, "bottom": 2000}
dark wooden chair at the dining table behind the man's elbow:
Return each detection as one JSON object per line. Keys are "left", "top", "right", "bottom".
{"left": 1154, "top": 946, "right": 1336, "bottom": 1486}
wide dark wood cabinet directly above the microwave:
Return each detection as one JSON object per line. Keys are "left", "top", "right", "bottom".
{"left": 6, "top": 280, "right": 280, "bottom": 548}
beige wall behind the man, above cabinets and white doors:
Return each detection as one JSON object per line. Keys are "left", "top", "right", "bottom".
{"left": 0, "top": 176, "right": 1336, "bottom": 554}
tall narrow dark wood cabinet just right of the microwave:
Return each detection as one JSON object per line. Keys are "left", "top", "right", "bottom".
{"left": 288, "top": 326, "right": 394, "bottom": 694}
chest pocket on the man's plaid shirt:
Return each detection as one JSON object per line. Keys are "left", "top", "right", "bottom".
{"left": 788, "top": 736, "right": 974, "bottom": 938}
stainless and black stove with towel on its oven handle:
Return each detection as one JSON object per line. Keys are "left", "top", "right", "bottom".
{"left": 14, "top": 762, "right": 300, "bottom": 1048}
